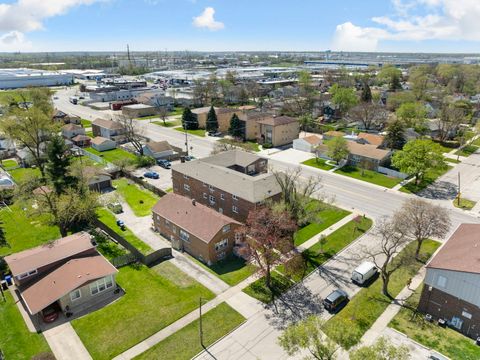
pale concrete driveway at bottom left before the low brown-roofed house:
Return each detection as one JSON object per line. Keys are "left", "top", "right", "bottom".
{"left": 43, "top": 322, "right": 92, "bottom": 360}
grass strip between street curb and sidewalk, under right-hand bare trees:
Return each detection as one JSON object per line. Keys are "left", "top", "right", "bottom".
{"left": 325, "top": 240, "right": 440, "bottom": 349}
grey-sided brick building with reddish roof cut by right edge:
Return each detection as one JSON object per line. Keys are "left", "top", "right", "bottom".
{"left": 418, "top": 224, "right": 480, "bottom": 339}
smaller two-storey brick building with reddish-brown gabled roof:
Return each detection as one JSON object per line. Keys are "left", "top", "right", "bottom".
{"left": 152, "top": 194, "right": 241, "bottom": 265}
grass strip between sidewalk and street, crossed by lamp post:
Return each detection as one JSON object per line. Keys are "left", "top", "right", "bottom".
{"left": 135, "top": 303, "right": 245, "bottom": 360}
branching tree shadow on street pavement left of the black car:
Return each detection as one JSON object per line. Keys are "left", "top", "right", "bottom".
{"left": 265, "top": 283, "right": 323, "bottom": 330}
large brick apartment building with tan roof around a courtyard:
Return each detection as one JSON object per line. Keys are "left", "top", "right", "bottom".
{"left": 172, "top": 150, "right": 281, "bottom": 222}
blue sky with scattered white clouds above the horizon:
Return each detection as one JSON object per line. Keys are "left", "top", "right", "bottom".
{"left": 0, "top": 0, "right": 480, "bottom": 52}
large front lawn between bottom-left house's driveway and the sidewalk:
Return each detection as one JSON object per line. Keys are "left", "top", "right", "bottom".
{"left": 72, "top": 262, "right": 214, "bottom": 360}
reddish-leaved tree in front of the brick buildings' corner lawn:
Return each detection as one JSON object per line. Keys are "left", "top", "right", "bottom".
{"left": 237, "top": 206, "right": 297, "bottom": 294}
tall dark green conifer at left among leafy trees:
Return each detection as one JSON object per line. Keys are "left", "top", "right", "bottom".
{"left": 45, "top": 135, "right": 77, "bottom": 195}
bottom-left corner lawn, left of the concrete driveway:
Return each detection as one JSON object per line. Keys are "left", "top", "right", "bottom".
{"left": 0, "top": 291, "right": 50, "bottom": 360}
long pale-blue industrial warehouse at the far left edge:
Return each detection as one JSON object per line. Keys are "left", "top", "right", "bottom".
{"left": 0, "top": 68, "right": 73, "bottom": 89}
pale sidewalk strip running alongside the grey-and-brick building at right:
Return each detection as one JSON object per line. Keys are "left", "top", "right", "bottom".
{"left": 361, "top": 267, "right": 425, "bottom": 345}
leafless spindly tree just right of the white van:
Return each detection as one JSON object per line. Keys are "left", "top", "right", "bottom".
{"left": 366, "top": 218, "right": 413, "bottom": 299}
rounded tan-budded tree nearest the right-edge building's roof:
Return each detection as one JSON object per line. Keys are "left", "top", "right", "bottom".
{"left": 394, "top": 198, "right": 451, "bottom": 260}
